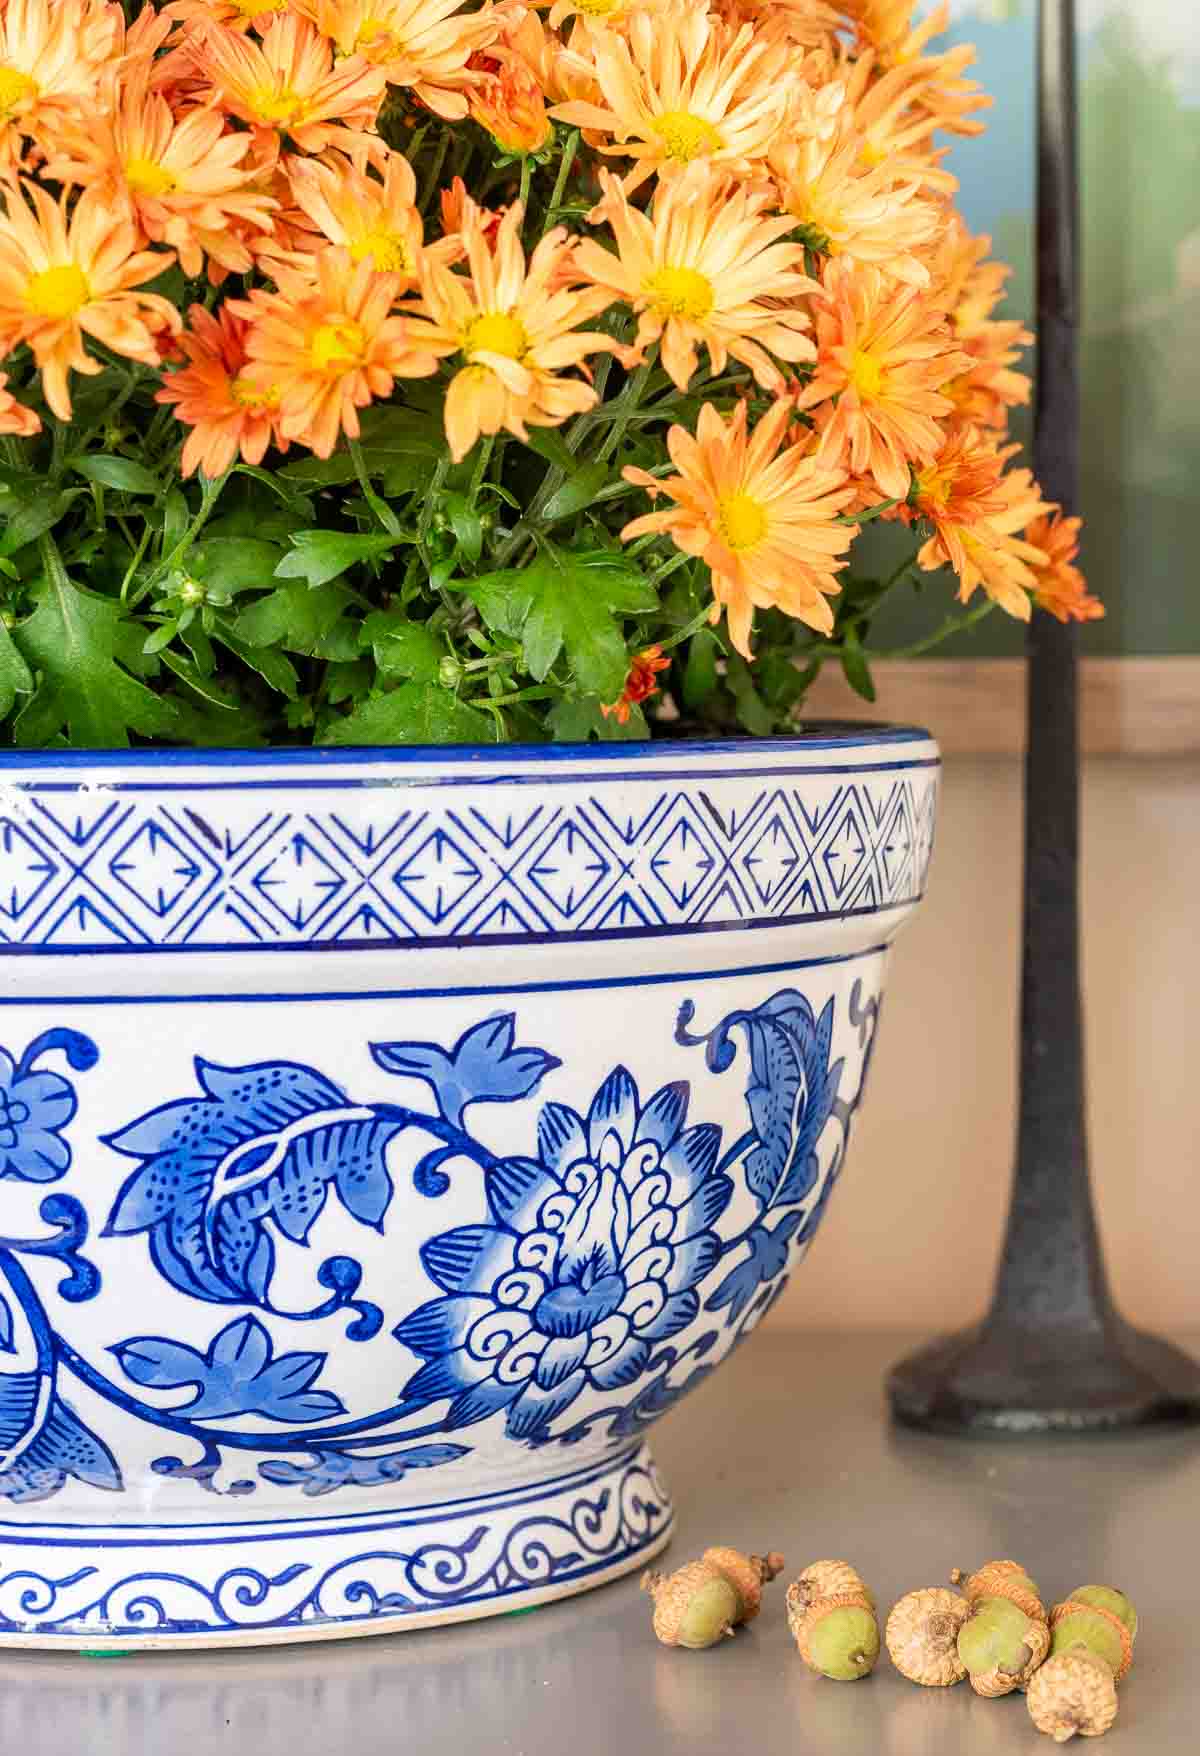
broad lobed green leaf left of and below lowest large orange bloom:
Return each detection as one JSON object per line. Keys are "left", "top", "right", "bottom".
{"left": 466, "top": 544, "right": 657, "bottom": 701}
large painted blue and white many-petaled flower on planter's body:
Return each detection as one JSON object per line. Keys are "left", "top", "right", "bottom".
{"left": 394, "top": 1068, "right": 733, "bottom": 1442}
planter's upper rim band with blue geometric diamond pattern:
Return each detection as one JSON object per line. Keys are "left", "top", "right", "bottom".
{"left": 0, "top": 762, "right": 936, "bottom": 955}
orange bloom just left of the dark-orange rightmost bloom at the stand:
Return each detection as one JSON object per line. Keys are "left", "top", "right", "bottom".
{"left": 901, "top": 427, "right": 1051, "bottom": 622}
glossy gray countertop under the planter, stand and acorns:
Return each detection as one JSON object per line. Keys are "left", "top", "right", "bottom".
{"left": 0, "top": 1331, "right": 1200, "bottom": 1756}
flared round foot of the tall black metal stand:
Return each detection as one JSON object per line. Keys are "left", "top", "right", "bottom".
{"left": 887, "top": 1317, "right": 1200, "bottom": 1435}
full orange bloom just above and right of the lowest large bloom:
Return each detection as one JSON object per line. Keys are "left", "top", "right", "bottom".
{"left": 799, "top": 267, "right": 970, "bottom": 499}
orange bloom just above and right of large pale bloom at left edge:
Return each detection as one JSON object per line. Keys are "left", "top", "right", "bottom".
{"left": 46, "top": 84, "right": 278, "bottom": 276}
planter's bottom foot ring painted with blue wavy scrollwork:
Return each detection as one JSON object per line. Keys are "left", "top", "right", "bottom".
{"left": 0, "top": 1445, "right": 673, "bottom": 1652}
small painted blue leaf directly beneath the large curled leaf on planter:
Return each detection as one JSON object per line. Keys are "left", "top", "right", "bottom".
{"left": 112, "top": 1317, "right": 344, "bottom": 1422}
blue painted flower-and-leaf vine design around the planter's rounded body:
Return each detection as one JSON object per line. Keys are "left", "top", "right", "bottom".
{"left": 0, "top": 983, "right": 877, "bottom": 1517}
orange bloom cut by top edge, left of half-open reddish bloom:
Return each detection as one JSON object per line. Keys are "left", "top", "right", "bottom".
{"left": 292, "top": 0, "right": 497, "bottom": 121}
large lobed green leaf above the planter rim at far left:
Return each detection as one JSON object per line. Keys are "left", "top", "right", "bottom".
{"left": 12, "top": 579, "right": 174, "bottom": 750}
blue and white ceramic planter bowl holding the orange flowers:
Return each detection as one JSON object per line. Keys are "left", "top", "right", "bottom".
{"left": 0, "top": 729, "right": 938, "bottom": 1647}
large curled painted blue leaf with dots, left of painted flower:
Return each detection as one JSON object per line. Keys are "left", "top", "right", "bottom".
{"left": 105, "top": 1059, "right": 409, "bottom": 1305}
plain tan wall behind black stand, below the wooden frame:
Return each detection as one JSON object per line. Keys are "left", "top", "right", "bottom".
{"left": 773, "top": 759, "right": 1200, "bottom": 1329}
